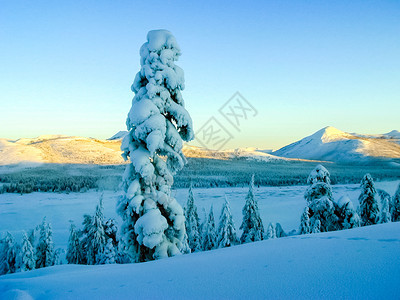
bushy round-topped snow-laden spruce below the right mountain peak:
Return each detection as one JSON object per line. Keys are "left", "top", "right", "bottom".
{"left": 304, "top": 165, "right": 341, "bottom": 232}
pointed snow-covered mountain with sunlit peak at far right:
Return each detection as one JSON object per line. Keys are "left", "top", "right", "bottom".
{"left": 272, "top": 126, "right": 400, "bottom": 162}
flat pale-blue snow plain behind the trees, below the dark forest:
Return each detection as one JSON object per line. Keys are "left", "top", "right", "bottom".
{"left": 0, "top": 180, "right": 400, "bottom": 249}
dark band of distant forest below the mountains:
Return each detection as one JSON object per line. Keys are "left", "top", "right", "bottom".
{"left": 0, "top": 158, "right": 400, "bottom": 194}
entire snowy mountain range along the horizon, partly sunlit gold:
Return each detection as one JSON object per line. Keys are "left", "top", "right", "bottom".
{"left": 0, "top": 127, "right": 400, "bottom": 165}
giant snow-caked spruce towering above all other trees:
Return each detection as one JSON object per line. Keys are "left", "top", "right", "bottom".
{"left": 118, "top": 30, "right": 194, "bottom": 261}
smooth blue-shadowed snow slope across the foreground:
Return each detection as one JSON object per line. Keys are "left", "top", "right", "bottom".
{"left": 0, "top": 222, "right": 400, "bottom": 299}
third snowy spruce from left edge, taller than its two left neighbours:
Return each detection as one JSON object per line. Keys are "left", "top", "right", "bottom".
{"left": 36, "top": 217, "right": 54, "bottom": 269}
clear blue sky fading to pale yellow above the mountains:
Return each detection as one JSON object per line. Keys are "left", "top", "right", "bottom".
{"left": 0, "top": 0, "right": 400, "bottom": 149}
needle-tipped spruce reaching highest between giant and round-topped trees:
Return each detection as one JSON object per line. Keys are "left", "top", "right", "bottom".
{"left": 240, "top": 174, "right": 264, "bottom": 244}
